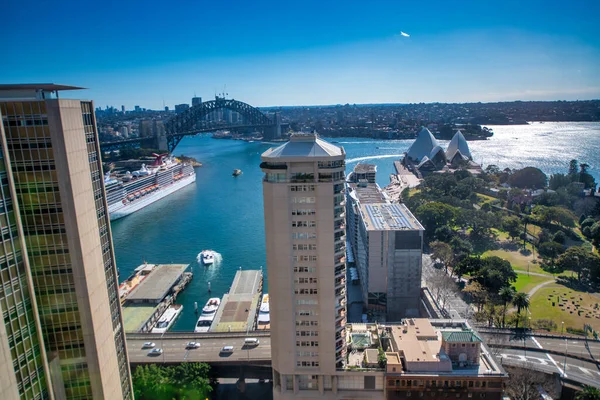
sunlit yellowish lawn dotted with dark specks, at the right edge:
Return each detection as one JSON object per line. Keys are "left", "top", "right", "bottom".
{"left": 529, "top": 283, "right": 600, "bottom": 332}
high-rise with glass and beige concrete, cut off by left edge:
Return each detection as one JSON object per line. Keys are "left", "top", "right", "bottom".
{"left": 0, "top": 84, "right": 133, "bottom": 399}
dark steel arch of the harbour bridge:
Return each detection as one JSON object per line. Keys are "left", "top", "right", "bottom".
{"left": 165, "top": 97, "right": 276, "bottom": 151}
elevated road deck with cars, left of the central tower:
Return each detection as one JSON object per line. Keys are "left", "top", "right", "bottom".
{"left": 127, "top": 335, "right": 271, "bottom": 365}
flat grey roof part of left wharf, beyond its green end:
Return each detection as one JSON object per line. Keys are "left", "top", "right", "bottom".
{"left": 127, "top": 264, "right": 188, "bottom": 303}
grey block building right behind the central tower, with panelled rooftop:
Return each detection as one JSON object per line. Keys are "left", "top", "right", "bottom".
{"left": 346, "top": 164, "right": 424, "bottom": 321}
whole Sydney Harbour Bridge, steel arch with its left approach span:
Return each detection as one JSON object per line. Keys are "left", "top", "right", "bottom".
{"left": 100, "top": 97, "right": 281, "bottom": 152}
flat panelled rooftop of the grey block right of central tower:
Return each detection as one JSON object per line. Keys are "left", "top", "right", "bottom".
{"left": 360, "top": 203, "right": 424, "bottom": 231}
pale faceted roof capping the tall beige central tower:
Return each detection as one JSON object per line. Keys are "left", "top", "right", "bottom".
{"left": 261, "top": 133, "right": 346, "bottom": 161}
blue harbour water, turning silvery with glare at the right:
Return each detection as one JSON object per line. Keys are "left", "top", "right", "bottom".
{"left": 112, "top": 122, "right": 600, "bottom": 331}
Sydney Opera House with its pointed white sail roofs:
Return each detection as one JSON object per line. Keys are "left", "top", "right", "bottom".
{"left": 403, "top": 128, "right": 479, "bottom": 173}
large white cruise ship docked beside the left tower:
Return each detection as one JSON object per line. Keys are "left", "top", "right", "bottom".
{"left": 104, "top": 154, "right": 196, "bottom": 221}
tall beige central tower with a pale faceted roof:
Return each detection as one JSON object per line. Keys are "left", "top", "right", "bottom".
{"left": 261, "top": 134, "right": 346, "bottom": 399}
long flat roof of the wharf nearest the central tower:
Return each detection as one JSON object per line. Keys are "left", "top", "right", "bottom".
{"left": 210, "top": 270, "right": 263, "bottom": 332}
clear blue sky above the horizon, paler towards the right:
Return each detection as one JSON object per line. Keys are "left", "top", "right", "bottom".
{"left": 0, "top": 0, "right": 600, "bottom": 109}
